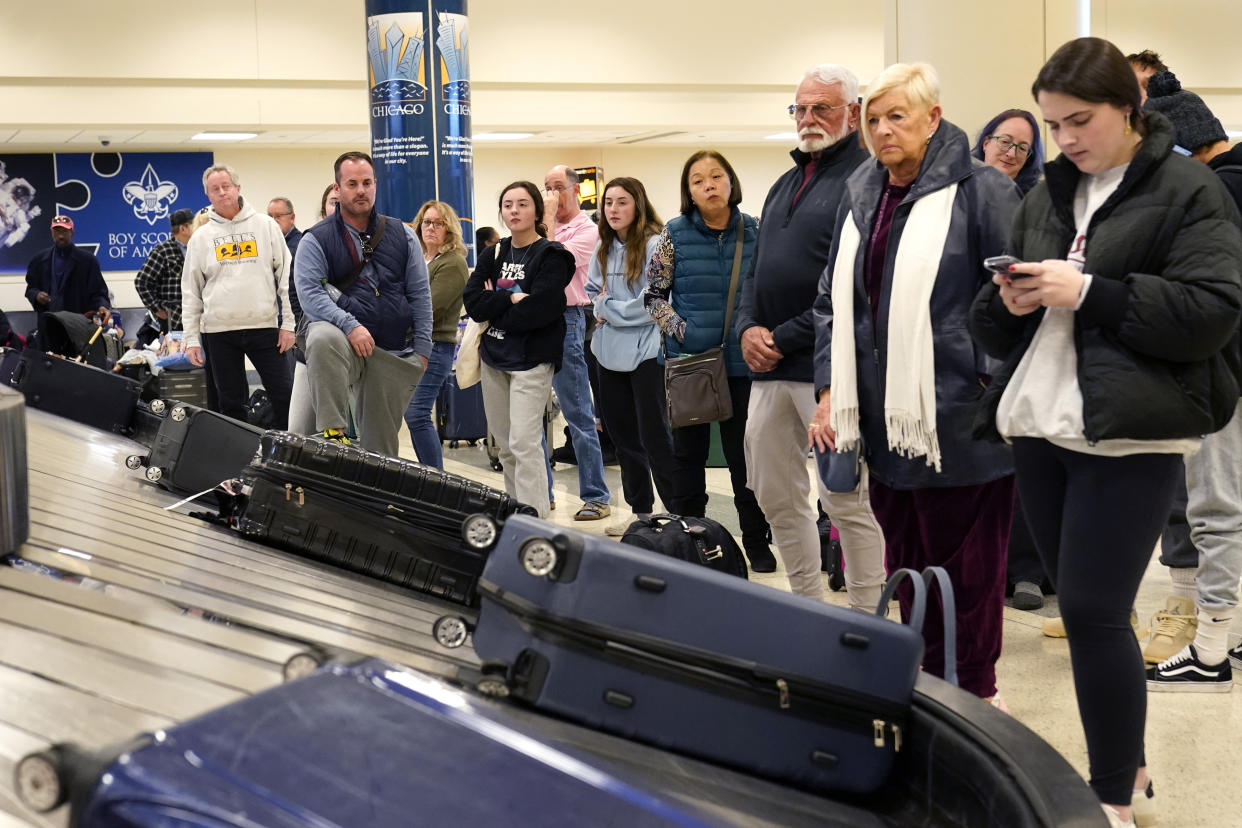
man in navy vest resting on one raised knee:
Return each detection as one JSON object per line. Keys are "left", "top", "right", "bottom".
{"left": 293, "top": 153, "right": 432, "bottom": 457}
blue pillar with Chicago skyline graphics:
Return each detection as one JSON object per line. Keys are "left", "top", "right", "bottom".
{"left": 366, "top": 0, "right": 474, "bottom": 261}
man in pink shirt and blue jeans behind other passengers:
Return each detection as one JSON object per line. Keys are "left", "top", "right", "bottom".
{"left": 544, "top": 164, "right": 611, "bottom": 520}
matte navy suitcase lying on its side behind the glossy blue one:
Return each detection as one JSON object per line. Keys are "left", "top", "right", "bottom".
{"left": 466, "top": 516, "right": 923, "bottom": 793}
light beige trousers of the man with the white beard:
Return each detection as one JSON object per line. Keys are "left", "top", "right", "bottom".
{"left": 746, "top": 380, "right": 884, "bottom": 612}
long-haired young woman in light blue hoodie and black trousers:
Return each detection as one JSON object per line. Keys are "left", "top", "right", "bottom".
{"left": 586, "top": 178, "right": 677, "bottom": 535}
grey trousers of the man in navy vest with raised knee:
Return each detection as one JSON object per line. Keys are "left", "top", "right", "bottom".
{"left": 307, "top": 322, "right": 424, "bottom": 457}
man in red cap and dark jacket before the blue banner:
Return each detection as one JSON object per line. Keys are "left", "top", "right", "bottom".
{"left": 26, "top": 216, "right": 112, "bottom": 324}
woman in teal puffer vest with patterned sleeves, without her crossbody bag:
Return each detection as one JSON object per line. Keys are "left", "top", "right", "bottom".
{"left": 645, "top": 150, "right": 776, "bottom": 572}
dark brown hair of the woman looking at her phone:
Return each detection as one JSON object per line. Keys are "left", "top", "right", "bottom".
{"left": 1031, "top": 37, "right": 1143, "bottom": 134}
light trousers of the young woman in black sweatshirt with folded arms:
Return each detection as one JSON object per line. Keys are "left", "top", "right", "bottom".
{"left": 479, "top": 362, "right": 553, "bottom": 519}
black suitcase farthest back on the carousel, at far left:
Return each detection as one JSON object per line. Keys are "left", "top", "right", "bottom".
{"left": 12, "top": 349, "right": 143, "bottom": 434}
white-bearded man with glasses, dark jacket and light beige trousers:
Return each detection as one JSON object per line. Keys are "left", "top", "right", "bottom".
{"left": 737, "top": 63, "right": 884, "bottom": 612}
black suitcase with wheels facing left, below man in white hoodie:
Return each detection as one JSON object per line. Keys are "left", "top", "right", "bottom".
{"left": 125, "top": 400, "right": 263, "bottom": 494}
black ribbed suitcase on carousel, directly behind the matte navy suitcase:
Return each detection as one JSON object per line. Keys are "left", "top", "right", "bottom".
{"left": 237, "top": 431, "right": 534, "bottom": 606}
